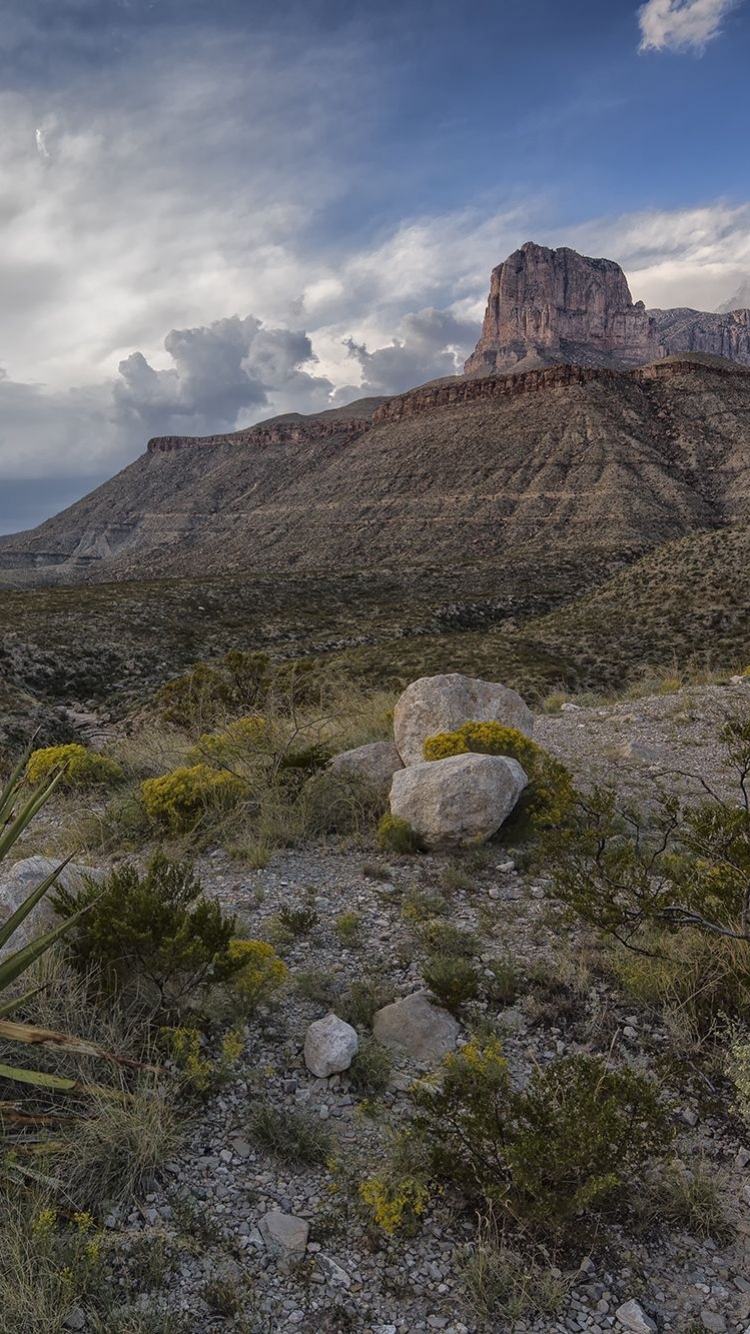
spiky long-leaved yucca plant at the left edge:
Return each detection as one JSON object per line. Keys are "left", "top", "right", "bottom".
{"left": 0, "top": 756, "right": 151, "bottom": 1177}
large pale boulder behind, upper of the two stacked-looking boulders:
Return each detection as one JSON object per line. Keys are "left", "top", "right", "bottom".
{"left": 394, "top": 672, "right": 534, "bottom": 766}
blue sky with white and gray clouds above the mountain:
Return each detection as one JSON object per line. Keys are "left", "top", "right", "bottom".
{"left": 0, "top": 0, "right": 750, "bottom": 532}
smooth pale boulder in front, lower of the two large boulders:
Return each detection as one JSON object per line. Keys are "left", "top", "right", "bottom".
{"left": 391, "top": 754, "right": 528, "bottom": 848}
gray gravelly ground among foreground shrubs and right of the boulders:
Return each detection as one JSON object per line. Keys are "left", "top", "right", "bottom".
{"left": 52, "top": 686, "right": 750, "bottom": 1334}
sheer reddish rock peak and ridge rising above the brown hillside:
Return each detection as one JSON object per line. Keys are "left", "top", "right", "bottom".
{"left": 464, "top": 241, "right": 750, "bottom": 375}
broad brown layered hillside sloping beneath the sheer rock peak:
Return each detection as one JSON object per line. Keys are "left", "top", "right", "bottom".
{"left": 0, "top": 358, "right": 750, "bottom": 582}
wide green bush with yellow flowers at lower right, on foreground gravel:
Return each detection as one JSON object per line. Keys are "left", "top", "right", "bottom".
{"left": 411, "top": 1039, "right": 670, "bottom": 1231}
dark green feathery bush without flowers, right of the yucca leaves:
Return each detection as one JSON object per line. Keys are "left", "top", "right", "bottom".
{"left": 53, "top": 852, "right": 247, "bottom": 1010}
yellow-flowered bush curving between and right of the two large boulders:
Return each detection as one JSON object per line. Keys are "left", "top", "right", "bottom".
{"left": 424, "top": 723, "right": 574, "bottom": 838}
